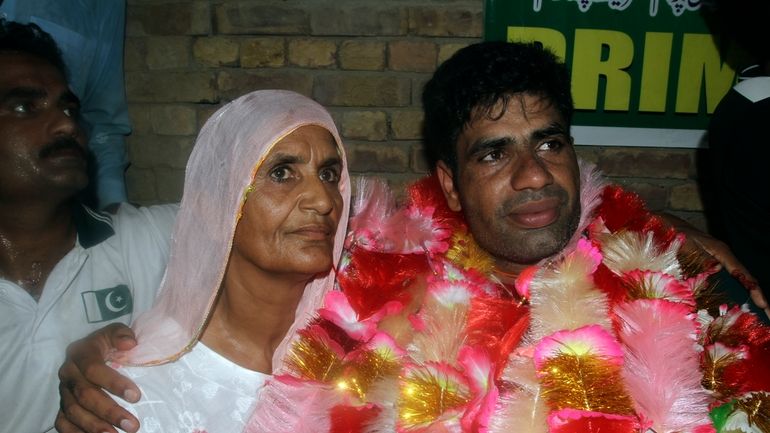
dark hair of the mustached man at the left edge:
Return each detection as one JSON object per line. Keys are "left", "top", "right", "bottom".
{"left": 0, "top": 19, "right": 67, "bottom": 80}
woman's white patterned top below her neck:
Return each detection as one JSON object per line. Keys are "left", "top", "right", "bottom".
{"left": 116, "top": 342, "right": 268, "bottom": 433}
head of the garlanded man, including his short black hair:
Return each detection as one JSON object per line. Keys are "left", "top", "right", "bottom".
{"left": 423, "top": 42, "right": 764, "bottom": 306}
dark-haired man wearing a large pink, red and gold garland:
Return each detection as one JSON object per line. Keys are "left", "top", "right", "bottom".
{"left": 57, "top": 42, "right": 770, "bottom": 433}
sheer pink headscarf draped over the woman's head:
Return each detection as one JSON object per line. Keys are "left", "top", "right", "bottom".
{"left": 113, "top": 90, "right": 350, "bottom": 368}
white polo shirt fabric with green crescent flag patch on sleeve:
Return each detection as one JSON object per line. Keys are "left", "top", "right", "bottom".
{"left": 0, "top": 204, "right": 177, "bottom": 433}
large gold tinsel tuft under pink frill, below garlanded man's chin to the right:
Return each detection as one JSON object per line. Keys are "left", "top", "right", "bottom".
{"left": 539, "top": 353, "right": 634, "bottom": 415}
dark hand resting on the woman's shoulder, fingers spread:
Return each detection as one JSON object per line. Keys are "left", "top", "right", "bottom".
{"left": 55, "top": 323, "right": 140, "bottom": 433}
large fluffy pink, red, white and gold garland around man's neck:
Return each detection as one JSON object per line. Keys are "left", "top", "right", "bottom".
{"left": 246, "top": 167, "right": 770, "bottom": 433}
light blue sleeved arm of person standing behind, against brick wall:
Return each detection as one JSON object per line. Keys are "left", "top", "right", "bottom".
{"left": 81, "top": 1, "right": 131, "bottom": 209}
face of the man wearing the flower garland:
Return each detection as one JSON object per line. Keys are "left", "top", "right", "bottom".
{"left": 438, "top": 94, "right": 580, "bottom": 273}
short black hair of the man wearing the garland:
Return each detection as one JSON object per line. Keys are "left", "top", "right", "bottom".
{"left": 422, "top": 41, "right": 568, "bottom": 173}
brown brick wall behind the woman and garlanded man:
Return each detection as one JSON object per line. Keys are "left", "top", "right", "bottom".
{"left": 125, "top": 0, "right": 705, "bottom": 227}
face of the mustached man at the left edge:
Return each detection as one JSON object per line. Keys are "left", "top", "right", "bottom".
{"left": 0, "top": 52, "right": 88, "bottom": 201}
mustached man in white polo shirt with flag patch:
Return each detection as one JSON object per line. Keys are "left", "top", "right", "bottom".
{"left": 0, "top": 20, "right": 176, "bottom": 433}
